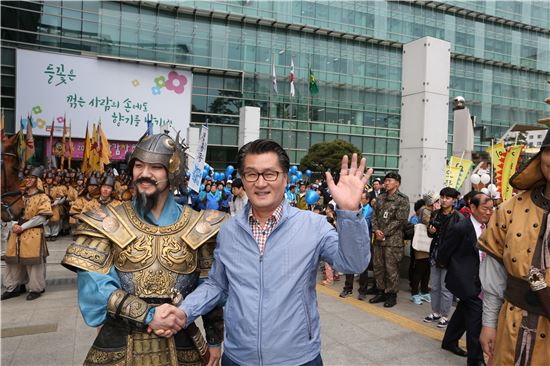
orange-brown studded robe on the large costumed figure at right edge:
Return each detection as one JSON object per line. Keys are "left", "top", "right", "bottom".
{"left": 479, "top": 188, "right": 550, "bottom": 366}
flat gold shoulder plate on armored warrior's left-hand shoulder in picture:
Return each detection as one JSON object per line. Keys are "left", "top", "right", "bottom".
{"left": 77, "top": 206, "right": 136, "bottom": 248}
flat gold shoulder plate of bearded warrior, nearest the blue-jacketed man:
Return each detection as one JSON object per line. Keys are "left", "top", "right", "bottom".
{"left": 181, "top": 206, "right": 229, "bottom": 250}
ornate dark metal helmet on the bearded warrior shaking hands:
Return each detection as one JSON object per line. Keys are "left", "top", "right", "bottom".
{"left": 128, "top": 133, "right": 188, "bottom": 186}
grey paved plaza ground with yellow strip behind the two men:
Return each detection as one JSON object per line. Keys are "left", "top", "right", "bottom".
{"left": 0, "top": 238, "right": 466, "bottom": 366}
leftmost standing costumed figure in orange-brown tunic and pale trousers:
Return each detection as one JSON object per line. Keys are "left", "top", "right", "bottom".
{"left": 2, "top": 168, "right": 52, "bottom": 300}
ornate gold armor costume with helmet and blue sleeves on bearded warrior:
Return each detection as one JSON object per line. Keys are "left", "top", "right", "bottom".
{"left": 62, "top": 134, "right": 227, "bottom": 366}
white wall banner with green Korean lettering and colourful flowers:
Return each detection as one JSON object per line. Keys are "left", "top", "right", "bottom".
{"left": 16, "top": 49, "right": 193, "bottom": 141}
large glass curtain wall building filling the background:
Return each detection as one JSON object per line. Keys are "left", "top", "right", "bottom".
{"left": 1, "top": 0, "right": 550, "bottom": 170}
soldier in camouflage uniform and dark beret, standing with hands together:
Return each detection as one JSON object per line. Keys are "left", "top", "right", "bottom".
{"left": 369, "top": 172, "right": 410, "bottom": 307}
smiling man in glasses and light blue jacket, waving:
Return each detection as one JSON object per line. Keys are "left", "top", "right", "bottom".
{"left": 152, "top": 139, "right": 372, "bottom": 365}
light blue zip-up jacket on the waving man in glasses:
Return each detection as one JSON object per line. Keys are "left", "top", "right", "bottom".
{"left": 180, "top": 200, "right": 370, "bottom": 365}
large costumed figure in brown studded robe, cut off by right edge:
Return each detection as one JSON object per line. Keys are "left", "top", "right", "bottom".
{"left": 479, "top": 134, "right": 550, "bottom": 365}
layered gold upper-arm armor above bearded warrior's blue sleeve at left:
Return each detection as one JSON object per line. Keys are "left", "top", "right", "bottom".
{"left": 61, "top": 235, "right": 114, "bottom": 274}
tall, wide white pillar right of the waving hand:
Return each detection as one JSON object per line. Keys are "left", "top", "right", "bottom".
{"left": 399, "top": 37, "right": 451, "bottom": 204}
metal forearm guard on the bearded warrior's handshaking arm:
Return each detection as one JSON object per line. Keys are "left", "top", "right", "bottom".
{"left": 107, "top": 289, "right": 152, "bottom": 330}
